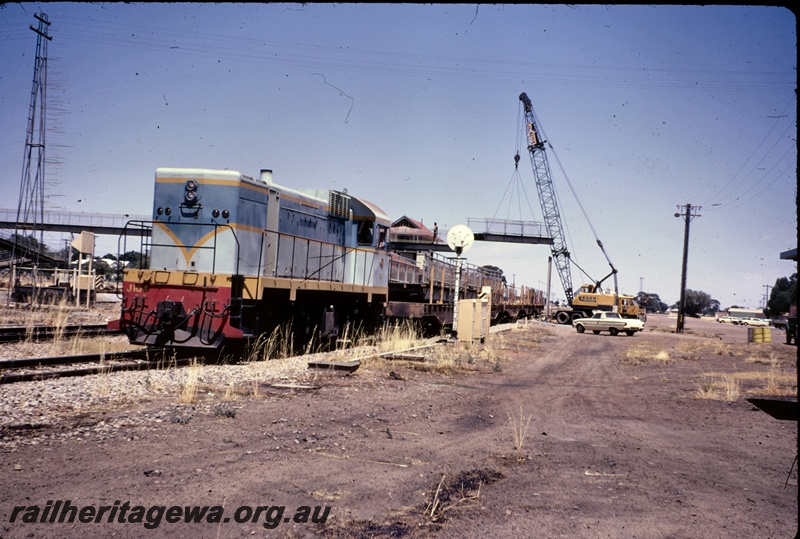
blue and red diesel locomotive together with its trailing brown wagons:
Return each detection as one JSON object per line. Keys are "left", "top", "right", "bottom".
{"left": 118, "top": 168, "right": 544, "bottom": 348}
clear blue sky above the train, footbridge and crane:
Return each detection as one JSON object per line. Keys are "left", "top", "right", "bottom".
{"left": 0, "top": 2, "right": 797, "bottom": 308}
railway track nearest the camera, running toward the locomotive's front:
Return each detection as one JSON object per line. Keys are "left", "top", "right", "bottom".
{"left": 0, "top": 348, "right": 195, "bottom": 385}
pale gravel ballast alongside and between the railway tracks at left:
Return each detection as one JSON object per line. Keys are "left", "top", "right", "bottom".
{"left": 0, "top": 304, "right": 444, "bottom": 452}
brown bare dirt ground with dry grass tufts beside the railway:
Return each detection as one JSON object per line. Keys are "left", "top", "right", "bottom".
{"left": 0, "top": 317, "right": 798, "bottom": 539}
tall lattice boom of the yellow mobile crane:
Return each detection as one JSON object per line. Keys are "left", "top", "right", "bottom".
{"left": 519, "top": 92, "right": 574, "bottom": 305}
